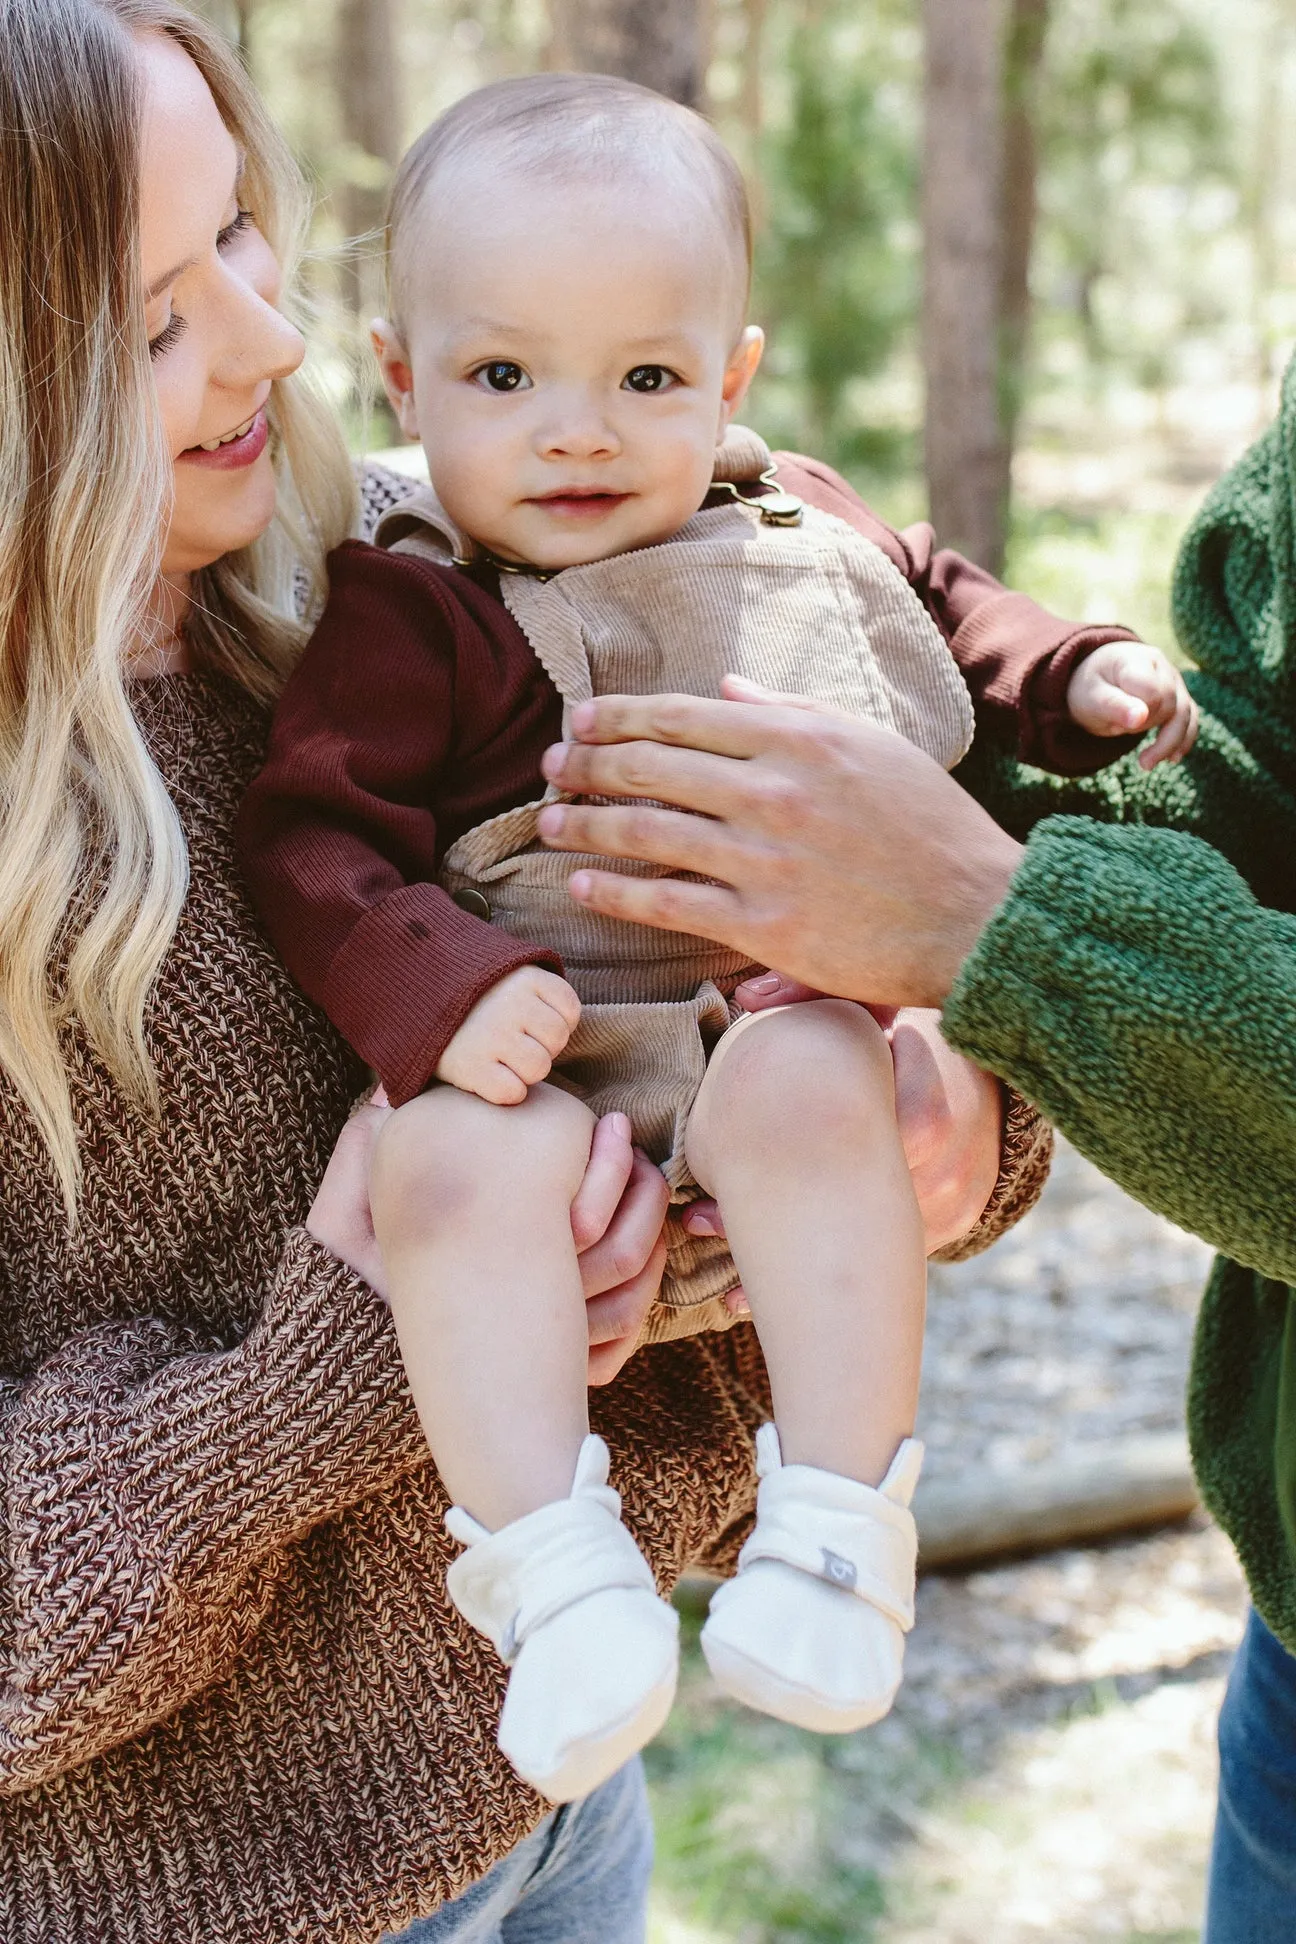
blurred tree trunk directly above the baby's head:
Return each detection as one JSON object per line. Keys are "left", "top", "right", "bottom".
{"left": 550, "top": 0, "right": 709, "bottom": 109}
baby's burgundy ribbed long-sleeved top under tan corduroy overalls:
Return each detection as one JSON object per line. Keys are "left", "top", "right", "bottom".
{"left": 239, "top": 455, "right": 1137, "bottom": 1106}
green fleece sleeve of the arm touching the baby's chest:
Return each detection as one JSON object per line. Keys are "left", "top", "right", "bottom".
{"left": 944, "top": 816, "right": 1296, "bottom": 1283}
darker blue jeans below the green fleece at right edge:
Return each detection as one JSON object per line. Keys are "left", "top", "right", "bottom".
{"left": 1201, "top": 1614, "right": 1296, "bottom": 1944}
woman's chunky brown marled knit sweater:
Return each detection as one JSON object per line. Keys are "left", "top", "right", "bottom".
{"left": 0, "top": 677, "right": 766, "bottom": 1944}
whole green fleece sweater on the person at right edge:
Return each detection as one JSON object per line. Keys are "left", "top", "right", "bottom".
{"left": 944, "top": 365, "right": 1296, "bottom": 1652}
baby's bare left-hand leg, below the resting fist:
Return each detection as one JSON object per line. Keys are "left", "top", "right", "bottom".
{"left": 371, "top": 1087, "right": 595, "bottom": 1530}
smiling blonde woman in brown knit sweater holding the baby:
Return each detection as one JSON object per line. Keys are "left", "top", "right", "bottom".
{"left": 0, "top": 0, "right": 1033, "bottom": 1944}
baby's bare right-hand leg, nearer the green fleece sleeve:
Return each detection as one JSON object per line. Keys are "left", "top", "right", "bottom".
{"left": 686, "top": 999, "right": 927, "bottom": 1485}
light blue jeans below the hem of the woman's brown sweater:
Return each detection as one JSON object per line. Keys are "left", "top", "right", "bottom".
{"left": 387, "top": 1755, "right": 653, "bottom": 1944}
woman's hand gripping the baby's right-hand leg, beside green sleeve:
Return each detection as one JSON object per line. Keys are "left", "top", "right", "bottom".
{"left": 684, "top": 987, "right": 1003, "bottom": 1259}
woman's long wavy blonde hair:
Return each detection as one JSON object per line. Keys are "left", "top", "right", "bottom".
{"left": 0, "top": 0, "right": 354, "bottom": 1221}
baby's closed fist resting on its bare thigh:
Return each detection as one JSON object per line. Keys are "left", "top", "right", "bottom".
{"left": 437, "top": 966, "right": 581, "bottom": 1106}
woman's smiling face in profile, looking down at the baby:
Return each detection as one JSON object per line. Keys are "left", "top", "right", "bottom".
{"left": 140, "top": 35, "right": 305, "bottom": 579}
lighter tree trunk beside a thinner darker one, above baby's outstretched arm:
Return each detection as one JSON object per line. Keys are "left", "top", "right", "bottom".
{"left": 923, "top": 0, "right": 1006, "bottom": 573}
